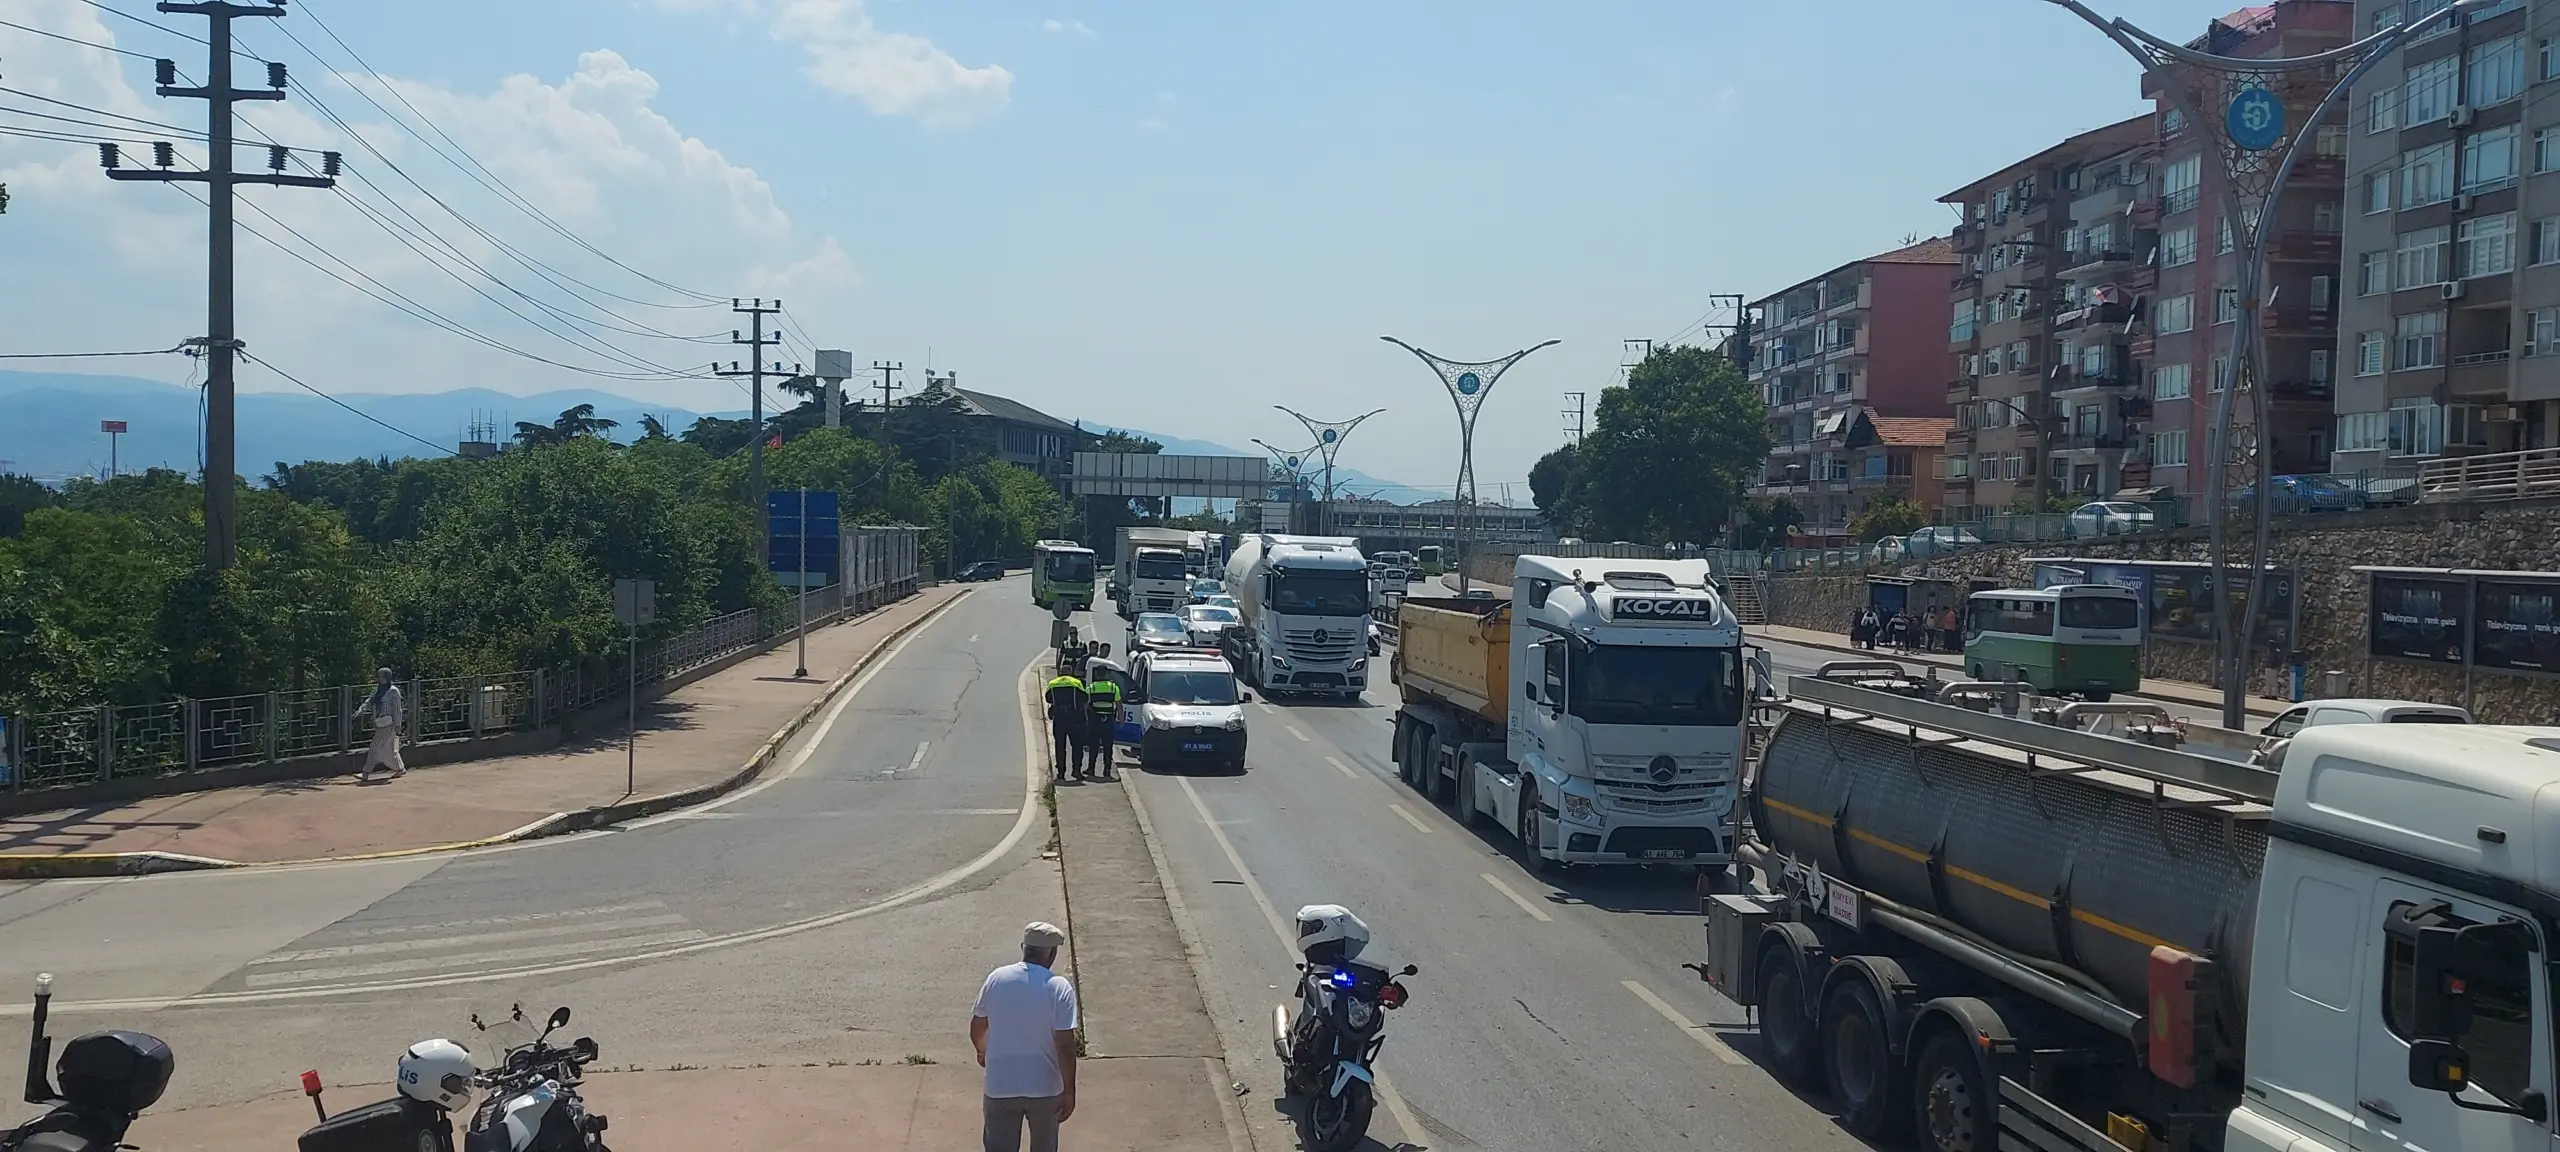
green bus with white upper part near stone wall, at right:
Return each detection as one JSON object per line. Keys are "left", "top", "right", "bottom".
{"left": 1964, "top": 584, "right": 2143, "bottom": 701}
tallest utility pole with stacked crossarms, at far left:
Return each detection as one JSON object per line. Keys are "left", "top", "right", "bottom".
{"left": 97, "top": 0, "right": 338, "bottom": 571}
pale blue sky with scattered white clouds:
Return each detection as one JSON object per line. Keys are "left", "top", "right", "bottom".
{"left": 0, "top": 0, "right": 2283, "bottom": 502}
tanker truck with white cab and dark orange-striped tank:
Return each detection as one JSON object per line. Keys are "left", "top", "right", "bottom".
{"left": 1697, "top": 668, "right": 2560, "bottom": 1152}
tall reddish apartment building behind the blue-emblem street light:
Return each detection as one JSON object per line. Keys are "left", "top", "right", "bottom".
{"left": 2125, "top": 0, "right": 2344, "bottom": 515}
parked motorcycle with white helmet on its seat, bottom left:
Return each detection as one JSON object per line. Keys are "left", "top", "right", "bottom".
{"left": 300, "top": 1004, "right": 609, "bottom": 1152}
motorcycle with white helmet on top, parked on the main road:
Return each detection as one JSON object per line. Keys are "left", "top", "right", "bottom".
{"left": 1272, "top": 904, "right": 1421, "bottom": 1152}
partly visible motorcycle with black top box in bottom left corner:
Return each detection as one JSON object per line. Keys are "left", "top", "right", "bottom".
{"left": 0, "top": 973, "right": 177, "bottom": 1152}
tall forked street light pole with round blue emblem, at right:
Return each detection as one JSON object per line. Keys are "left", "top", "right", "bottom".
{"left": 2045, "top": 0, "right": 2496, "bottom": 727}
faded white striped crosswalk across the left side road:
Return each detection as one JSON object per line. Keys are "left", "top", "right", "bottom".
{"left": 241, "top": 901, "right": 709, "bottom": 991}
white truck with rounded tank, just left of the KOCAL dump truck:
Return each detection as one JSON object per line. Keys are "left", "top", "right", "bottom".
{"left": 1226, "top": 532, "right": 1370, "bottom": 699}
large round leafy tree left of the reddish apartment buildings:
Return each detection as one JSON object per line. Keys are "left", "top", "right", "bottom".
{"left": 1572, "top": 346, "right": 1769, "bottom": 543}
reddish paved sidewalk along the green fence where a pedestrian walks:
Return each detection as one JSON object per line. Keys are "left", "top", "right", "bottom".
{"left": 0, "top": 584, "right": 965, "bottom": 876}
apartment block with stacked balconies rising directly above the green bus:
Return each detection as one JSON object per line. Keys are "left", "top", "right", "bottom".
{"left": 1940, "top": 115, "right": 2153, "bottom": 522}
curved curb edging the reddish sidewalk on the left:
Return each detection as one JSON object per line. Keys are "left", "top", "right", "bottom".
{"left": 0, "top": 589, "right": 978, "bottom": 881}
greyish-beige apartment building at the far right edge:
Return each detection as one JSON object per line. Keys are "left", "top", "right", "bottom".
{"left": 2330, "top": 0, "right": 2560, "bottom": 476}
